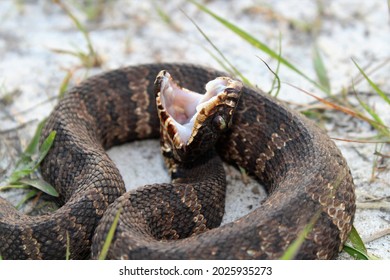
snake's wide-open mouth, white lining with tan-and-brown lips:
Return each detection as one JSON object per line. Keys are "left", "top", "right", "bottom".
{"left": 155, "top": 70, "right": 238, "bottom": 146}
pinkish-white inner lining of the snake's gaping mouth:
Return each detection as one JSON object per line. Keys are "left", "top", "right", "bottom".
{"left": 161, "top": 78, "right": 227, "bottom": 143}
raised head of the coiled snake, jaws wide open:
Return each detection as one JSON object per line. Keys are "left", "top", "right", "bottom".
{"left": 155, "top": 70, "right": 243, "bottom": 162}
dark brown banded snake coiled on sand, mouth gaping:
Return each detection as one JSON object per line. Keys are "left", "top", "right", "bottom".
{"left": 0, "top": 63, "right": 356, "bottom": 259}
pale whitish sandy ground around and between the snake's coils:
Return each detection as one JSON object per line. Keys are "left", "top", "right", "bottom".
{"left": 0, "top": 0, "right": 390, "bottom": 259}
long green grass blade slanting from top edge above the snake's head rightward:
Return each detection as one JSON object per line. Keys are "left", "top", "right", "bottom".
{"left": 189, "top": 0, "right": 326, "bottom": 92}
